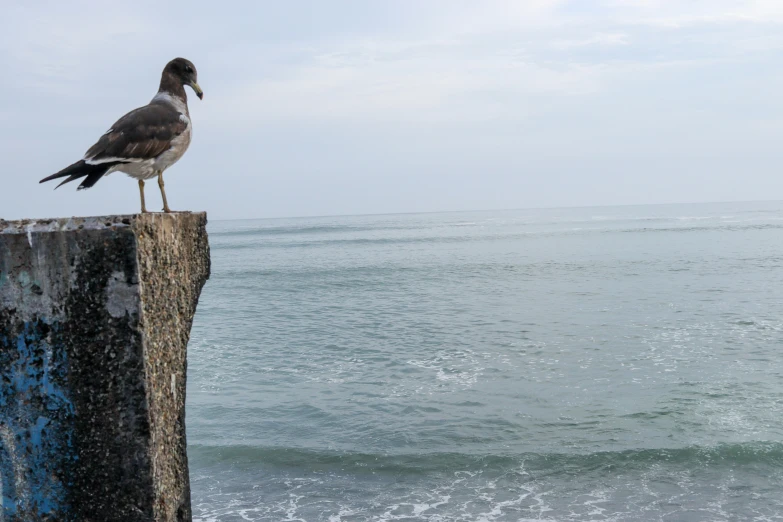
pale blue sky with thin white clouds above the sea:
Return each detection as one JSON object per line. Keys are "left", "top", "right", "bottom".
{"left": 0, "top": 0, "right": 783, "bottom": 219}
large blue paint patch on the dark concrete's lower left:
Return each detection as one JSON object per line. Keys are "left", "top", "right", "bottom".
{"left": 0, "top": 320, "right": 74, "bottom": 519}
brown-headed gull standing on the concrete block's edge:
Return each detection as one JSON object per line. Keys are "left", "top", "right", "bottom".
{"left": 39, "top": 58, "right": 204, "bottom": 213}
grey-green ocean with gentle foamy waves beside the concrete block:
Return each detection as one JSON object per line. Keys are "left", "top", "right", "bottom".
{"left": 187, "top": 202, "right": 783, "bottom": 522}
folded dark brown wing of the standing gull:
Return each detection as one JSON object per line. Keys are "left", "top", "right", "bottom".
{"left": 83, "top": 103, "right": 188, "bottom": 165}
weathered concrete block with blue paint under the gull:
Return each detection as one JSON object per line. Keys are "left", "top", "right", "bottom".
{"left": 0, "top": 214, "right": 210, "bottom": 522}
